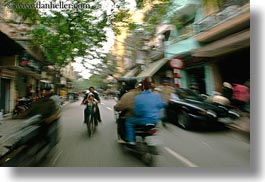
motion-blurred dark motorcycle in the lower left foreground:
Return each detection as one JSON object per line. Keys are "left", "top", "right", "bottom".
{"left": 0, "top": 115, "right": 59, "bottom": 167}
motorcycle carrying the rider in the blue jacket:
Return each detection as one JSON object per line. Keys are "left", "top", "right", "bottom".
{"left": 117, "top": 114, "right": 159, "bottom": 166}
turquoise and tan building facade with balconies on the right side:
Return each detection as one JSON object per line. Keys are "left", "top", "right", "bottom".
{"left": 122, "top": 0, "right": 250, "bottom": 95}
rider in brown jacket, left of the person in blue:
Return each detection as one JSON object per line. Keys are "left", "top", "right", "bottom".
{"left": 114, "top": 80, "right": 142, "bottom": 143}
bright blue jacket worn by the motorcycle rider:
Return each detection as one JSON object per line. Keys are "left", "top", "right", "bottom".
{"left": 134, "top": 90, "right": 166, "bottom": 123}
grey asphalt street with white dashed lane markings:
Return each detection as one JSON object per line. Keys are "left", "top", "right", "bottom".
{"left": 39, "top": 99, "right": 250, "bottom": 167}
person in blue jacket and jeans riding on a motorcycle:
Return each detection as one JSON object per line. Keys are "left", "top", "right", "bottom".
{"left": 125, "top": 77, "right": 166, "bottom": 147}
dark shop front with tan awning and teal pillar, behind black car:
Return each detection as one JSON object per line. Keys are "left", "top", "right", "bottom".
{"left": 192, "top": 29, "right": 250, "bottom": 95}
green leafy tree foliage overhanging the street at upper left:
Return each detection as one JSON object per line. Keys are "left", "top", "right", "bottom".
{"left": 5, "top": 0, "right": 128, "bottom": 66}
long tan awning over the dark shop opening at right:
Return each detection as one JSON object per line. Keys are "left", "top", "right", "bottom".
{"left": 192, "top": 29, "right": 250, "bottom": 57}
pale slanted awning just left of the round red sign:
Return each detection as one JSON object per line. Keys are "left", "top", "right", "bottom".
{"left": 136, "top": 58, "right": 169, "bottom": 78}
